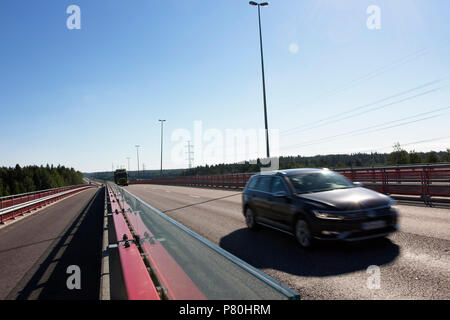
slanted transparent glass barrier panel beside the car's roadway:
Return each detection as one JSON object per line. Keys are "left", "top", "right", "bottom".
{"left": 107, "top": 185, "right": 299, "bottom": 300}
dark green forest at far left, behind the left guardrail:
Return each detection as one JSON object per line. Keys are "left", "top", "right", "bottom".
{"left": 0, "top": 165, "right": 84, "bottom": 197}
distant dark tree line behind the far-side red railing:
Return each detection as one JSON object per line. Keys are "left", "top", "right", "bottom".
{"left": 85, "top": 144, "right": 450, "bottom": 181}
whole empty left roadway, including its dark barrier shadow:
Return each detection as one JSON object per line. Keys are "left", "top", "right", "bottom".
{"left": 0, "top": 188, "right": 104, "bottom": 300}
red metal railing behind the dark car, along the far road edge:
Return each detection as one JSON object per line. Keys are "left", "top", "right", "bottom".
{"left": 131, "top": 164, "right": 450, "bottom": 199}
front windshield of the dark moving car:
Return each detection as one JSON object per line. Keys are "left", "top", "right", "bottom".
{"left": 289, "top": 170, "right": 354, "bottom": 193}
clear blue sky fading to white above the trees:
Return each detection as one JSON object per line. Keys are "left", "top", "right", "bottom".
{"left": 0, "top": 0, "right": 450, "bottom": 172}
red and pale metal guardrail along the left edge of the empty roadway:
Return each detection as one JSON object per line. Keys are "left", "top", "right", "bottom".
{"left": 0, "top": 185, "right": 91, "bottom": 224}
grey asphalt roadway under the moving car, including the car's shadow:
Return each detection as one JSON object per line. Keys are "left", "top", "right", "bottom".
{"left": 127, "top": 185, "right": 450, "bottom": 299}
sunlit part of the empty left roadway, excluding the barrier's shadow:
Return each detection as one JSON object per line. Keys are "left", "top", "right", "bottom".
{"left": 0, "top": 188, "right": 101, "bottom": 300}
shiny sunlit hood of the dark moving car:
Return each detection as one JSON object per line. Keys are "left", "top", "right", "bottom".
{"left": 298, "top": 187, "right": 391, "bottom": 210}
